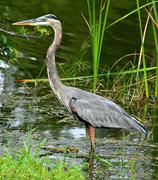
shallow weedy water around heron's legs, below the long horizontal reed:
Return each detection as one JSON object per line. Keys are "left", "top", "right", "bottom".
{"left": 0, "top": 63, "right": 158, "bottom": 179}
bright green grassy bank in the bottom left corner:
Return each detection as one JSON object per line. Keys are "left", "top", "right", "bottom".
{"left": 0, "top": 143, "right": 84, "bottom": 180}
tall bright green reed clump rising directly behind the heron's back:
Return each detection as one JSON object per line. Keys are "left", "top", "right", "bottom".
{"left": 86, "top": 0, "right": 110, "bottom": 93}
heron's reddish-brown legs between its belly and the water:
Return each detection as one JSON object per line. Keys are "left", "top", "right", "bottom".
{"left": 86, "top": 125, "right": 95, "bottom": 151}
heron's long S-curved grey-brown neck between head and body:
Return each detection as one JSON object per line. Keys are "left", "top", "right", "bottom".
{"left": 46, "top": 21, "right": 62, "bottom": 91}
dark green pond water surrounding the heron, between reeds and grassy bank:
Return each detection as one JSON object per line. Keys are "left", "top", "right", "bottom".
{"left": 0, "top": 0, "right": 158, "bottom": 179}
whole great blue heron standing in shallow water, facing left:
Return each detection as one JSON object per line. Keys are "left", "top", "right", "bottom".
{"left": 13, "top": 14, "right": 147, "bottom": 150}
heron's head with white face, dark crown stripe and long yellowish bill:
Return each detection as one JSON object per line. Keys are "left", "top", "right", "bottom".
{"left": 13, "top": 14, "right": 58, "bottom": 26}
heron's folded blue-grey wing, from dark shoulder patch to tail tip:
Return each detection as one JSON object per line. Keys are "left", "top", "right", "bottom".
{"left": 70, "top": 95, "right": 146, "bottom": 133}
